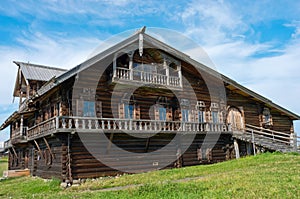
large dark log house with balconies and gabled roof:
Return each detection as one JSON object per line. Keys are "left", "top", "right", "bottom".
{"left": 1, "top": 29, "right": 300, "bottom": 181}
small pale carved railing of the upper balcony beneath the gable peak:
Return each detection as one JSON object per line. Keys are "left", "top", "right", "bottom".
{"left": 114, "top": 68, "right": 181, "bottom": 88}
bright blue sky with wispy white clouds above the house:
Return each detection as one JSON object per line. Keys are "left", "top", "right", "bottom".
{"left": 0, "top": 0, "right": 300, "bottom": 140}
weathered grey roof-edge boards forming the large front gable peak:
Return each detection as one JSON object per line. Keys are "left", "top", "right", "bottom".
{"left": 17, "top": 27, "right": 300, "bottom": 120}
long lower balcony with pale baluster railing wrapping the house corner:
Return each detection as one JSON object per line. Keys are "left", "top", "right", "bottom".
{"left": 27, "top": 116, "right": 231, "bottom": 140}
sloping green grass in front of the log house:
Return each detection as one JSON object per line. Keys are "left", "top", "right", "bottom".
{"left": 0, "top": 153, "right": 300, "bottom": 199}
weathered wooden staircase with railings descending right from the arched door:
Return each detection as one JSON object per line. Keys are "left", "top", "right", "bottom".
{"left": 233, "top": 125, "right": 300, "bottom": 153}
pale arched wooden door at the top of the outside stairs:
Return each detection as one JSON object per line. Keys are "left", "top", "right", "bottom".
{"left": 227, "top": 107, "right": 244, "bottom": 131}
